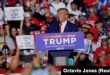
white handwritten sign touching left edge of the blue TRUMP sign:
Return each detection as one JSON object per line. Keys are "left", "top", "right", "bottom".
{"left": 16, "top": 35, "right": 35, "bottom": 49}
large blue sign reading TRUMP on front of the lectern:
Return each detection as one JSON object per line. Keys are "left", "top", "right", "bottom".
{"left": 35, "top": 32, "right": 84, "bottom": 51}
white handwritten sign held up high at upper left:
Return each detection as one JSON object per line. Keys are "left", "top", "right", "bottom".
{"left": 4, "top": 7, "right": 24, "bottom": 21}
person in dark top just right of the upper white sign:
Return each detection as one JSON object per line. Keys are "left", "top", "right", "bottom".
{"left": 20, "top": 7, "right": 38, "bottom": 35}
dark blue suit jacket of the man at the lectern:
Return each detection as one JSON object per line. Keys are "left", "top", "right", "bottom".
{"left": 47, "top": 20, "right": 78, "bottom": 33}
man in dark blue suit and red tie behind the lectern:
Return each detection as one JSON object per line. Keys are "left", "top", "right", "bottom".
{"left": 47, "top": 8, "right": 78, "bottom": 33}
